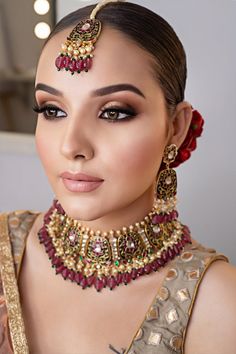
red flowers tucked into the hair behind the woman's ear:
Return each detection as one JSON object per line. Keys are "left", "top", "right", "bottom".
{"left": 171, "top": 109, "right": 204, "bottom": 167}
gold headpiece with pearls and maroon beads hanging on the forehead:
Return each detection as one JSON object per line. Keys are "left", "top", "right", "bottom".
{"left": 55, "top": 0, "right": 125, "bottom": 74}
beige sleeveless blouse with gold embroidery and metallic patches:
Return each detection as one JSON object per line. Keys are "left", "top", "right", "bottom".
{"left": 0, "top": 211, "right": 228, "bottom": 354}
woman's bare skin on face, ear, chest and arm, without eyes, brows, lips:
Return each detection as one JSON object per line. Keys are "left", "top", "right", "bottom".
{"left": 19, "top": 28, "right": 236, "bottom": 354}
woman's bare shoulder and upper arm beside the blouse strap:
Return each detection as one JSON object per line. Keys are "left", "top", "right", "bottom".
{"left": 184, "top": 261, "right": 236, "bottom": 354}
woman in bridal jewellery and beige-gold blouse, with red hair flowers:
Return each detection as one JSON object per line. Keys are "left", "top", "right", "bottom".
{"left": 0, "top": 1, "right": 236, "bottom": 354}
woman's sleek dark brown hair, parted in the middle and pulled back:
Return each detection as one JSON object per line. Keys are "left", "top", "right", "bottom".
{"left": 47, "top": 2, "right": 187, "bottom": 113}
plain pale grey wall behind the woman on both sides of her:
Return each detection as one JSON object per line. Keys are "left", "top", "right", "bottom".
{"left": 0, "top": 0, "right": 236, "bottom": 264}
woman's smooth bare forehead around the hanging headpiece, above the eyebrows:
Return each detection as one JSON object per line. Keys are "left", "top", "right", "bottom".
{"left": 36, "top": 28, "right": 159, "bottom": 98}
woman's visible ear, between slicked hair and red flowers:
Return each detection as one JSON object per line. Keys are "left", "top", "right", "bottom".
{"left": 169, "top": 101, "right": 192, "bottom": 148}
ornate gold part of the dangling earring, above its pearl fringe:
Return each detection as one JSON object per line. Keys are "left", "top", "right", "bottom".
{"left": 156, "top": 144, "right": 178, "bottom": 200}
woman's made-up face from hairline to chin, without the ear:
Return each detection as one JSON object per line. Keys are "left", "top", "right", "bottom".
{"left": 36, "top": 28, "right": 169, "bottom": 227}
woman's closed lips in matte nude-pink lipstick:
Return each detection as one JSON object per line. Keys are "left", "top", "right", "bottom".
{"left": 60, "top": 172, "right": 104, "bottom": 192}
